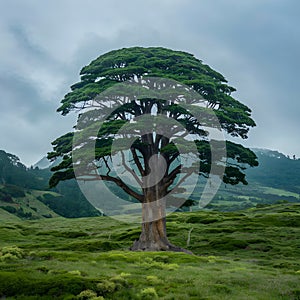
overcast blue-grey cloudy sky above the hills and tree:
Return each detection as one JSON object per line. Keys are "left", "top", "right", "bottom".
{"left": 0, "top": 0, "right": 300, "bottom": 166}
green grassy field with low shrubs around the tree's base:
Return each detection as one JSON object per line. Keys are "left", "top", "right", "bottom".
{"left": 0, "top": 204, "right": 300, "bottom": 300}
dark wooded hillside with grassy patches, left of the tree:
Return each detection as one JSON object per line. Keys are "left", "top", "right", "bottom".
{"left": 0, "top": 150, "right": 99, "bottom": 219}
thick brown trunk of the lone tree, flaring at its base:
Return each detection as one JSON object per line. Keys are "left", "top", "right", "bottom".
{"left": 130, "top": 191, "right": 192, "bottom": 254}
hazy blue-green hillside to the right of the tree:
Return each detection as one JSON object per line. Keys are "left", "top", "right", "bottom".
{"left": 191, "top": 149, "right": 300, "bottom": 211}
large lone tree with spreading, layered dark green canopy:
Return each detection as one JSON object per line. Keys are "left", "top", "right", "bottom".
{"left": 48, "top": 47, "right": 258, "bottom": 251}
